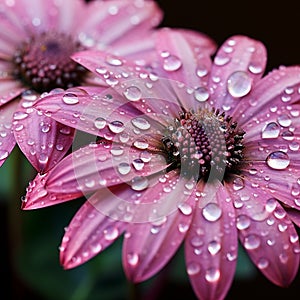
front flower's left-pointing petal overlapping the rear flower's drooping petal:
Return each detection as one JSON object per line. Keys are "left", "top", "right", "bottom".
{"left": 35, "top": 87, "right": 169, "bottom": 140}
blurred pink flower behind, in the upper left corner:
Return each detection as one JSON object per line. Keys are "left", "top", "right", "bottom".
{"left": 0, "top": 0, "right": 162, "bottom": 172}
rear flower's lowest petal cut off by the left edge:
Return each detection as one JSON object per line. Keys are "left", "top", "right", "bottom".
{"left": 0, "top": 101, "right": 18, "bottom": 166}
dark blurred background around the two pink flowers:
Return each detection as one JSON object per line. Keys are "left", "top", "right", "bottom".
{"left": 0, "top": 0, "right": 300, "bottom": 300}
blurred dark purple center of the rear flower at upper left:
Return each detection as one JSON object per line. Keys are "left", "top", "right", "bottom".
{"left": 13, "top": 32, "right": 87, "bottom": 93}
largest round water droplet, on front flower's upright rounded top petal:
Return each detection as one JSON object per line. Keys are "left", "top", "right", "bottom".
{"left": 227, "top": 71, "right": 252, "bottom": 98}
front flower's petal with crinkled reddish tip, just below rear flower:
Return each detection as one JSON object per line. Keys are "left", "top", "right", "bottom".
{"left": 23, "top": 143, "right": 167, "bottom": 209}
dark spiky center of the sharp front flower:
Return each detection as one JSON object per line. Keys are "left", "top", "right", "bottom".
{"left": 161, "top": 109, "right": 245, "bottom": 181}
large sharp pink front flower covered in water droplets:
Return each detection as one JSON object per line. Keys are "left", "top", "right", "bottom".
{"left": 23, "top": 29, "right": 300, "bottom": 300}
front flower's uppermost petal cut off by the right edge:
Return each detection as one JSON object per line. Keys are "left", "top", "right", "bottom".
{"left": 233, "top": 66, "right": 300, "bottom": 125}
